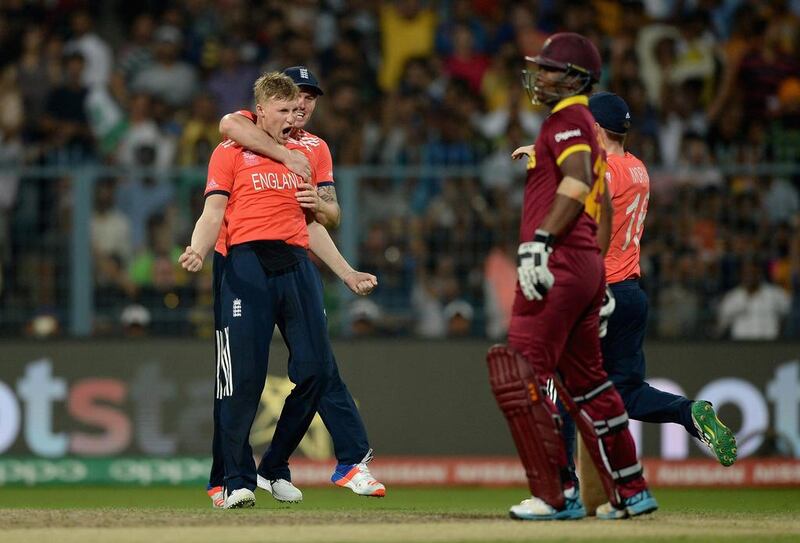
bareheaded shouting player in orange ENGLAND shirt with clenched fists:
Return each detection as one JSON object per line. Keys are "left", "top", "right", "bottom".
{"left": 180, "top": 73, "right": 377, "bottom": 508}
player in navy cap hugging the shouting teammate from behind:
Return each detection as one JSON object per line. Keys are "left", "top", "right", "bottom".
{"left": 203, "top": 66, "right": 386, "bottom": 507}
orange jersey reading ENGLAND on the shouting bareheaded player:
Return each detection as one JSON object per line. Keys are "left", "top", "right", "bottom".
{"left": 205, "top": 133, "right": 318, "bottom": 255}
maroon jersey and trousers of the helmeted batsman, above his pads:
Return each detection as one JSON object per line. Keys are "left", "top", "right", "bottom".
{"left": 508, "top": 95, "right": 607, "bottom": 372}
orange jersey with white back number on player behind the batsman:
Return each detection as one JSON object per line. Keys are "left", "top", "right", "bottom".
{"left": 606, "top": 152, "right": 650, "bottom": 283}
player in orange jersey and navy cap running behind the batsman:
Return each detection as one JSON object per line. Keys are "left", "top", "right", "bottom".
{"left": 576, "top": 92, "right": 736, "bottom": 466}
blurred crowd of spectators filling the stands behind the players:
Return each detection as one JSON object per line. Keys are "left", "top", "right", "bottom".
{"left": 0, "top": 0, "right": 800, "bottom": 339}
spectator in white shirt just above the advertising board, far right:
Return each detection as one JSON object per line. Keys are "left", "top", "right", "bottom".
{"left": 717, "top": 259, "right": 790, "bottom": 340}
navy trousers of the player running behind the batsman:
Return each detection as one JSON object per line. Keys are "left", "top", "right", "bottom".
{"left": 559, "top": 279, "right": 698, "bottom": 476}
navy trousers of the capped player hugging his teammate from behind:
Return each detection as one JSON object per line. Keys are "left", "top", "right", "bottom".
{"left": 209, "top": 252, "right": 369, "bottom": 487}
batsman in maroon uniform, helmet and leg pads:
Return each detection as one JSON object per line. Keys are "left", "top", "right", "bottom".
{"left": 487, "top": 33, "right": 658, "bottom": 520}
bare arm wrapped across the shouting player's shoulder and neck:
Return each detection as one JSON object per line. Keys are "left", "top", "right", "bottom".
{"left": 219, "top": 113, "right": 311, "bottom": 180}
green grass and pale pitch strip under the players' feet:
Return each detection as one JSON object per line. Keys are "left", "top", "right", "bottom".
{"left": 0, "top": 486, "right": 800, "bottom": 543}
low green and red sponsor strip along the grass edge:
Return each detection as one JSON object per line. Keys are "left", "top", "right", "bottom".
{"left": 0, "top": 457, "right": 800, "bottom": 488}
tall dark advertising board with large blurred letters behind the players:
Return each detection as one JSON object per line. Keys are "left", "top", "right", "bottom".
{"left": 0, "top": 339, "right": 800, "bottom": 464}
